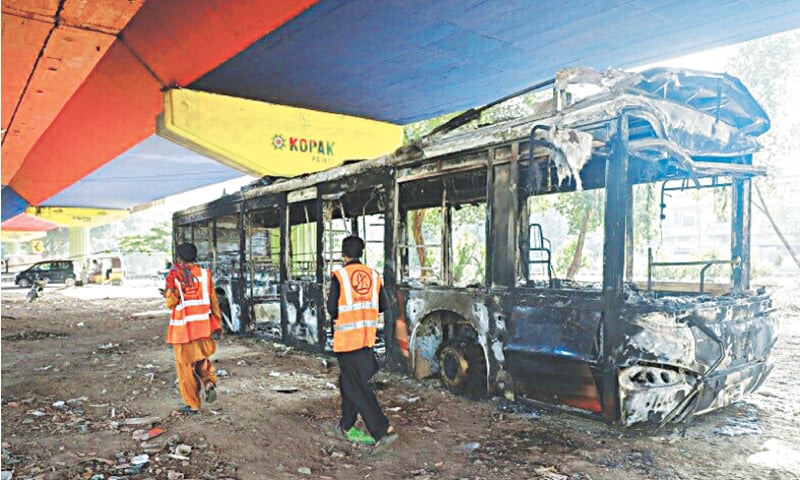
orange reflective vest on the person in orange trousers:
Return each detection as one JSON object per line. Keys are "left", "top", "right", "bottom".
{"left": 167, "top": 267, "right": 220, "bottom": 345}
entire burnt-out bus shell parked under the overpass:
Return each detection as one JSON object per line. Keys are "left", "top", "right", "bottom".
{"left": 173, "top": 68, "right": 776, "bottom": 426}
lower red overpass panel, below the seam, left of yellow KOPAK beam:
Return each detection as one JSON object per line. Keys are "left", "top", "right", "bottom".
{"left": 10, "top": 42, "right": 163, "bottom": 205}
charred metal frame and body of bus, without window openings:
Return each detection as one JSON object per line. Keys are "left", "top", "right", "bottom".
{"left": 174, "top": 66, "right": 775, "bottom": 425}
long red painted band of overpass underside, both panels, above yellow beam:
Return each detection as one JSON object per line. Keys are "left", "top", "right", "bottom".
{"left": 4, "top": 0, "right": 316, "bottom": 205}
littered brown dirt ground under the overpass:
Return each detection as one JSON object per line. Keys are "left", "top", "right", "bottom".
{"left": 2, "top": 286, "right": 800, "bottom": 480}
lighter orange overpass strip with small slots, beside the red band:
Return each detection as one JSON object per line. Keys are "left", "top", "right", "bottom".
{"left": 2, "top": 26, "right": 115, "bottom": 185}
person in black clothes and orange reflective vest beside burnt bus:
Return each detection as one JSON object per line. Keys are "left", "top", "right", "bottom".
{"left": 327, "top": 236, "right": 397, "bottom": 451}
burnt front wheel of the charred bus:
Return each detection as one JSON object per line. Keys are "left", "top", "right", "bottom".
{"left": 436, "top": 338, "right": 486, "bottom": 398}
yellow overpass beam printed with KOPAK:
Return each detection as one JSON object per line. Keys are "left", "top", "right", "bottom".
{"left": 158, "top": 89, "right": 403, "bottom": 177}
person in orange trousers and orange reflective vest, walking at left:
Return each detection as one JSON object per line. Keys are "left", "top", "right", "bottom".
{"left": 164, "top": 243, "right": 222, "bottom": 414}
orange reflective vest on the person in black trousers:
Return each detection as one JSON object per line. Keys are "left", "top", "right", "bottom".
{"left": 333, "top": 263, "right": 381, "bottom": 352}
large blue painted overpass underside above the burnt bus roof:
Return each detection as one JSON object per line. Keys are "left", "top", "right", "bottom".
{"left": 191, "top": 0, "right": 800, "bottom": 124}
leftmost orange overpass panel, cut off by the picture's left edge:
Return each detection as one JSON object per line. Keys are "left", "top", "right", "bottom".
{"left": 0, "top": 13, "right": 53, "bottom": 133}
